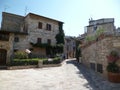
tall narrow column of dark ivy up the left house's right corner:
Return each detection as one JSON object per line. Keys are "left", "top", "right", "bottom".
{"left": 55, "top": 22, "right": 65, "bottom": 44}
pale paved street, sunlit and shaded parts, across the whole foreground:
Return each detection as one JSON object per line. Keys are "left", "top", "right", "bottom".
{"left": 0, "top": 59, "right": 120, "bottom": 90}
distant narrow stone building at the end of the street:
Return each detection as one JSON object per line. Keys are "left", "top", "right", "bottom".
{"left": 64, "top": 36, "right": 76, "bottom": 58}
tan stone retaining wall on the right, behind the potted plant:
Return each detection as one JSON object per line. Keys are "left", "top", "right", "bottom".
{"left": 82, "top": 36, "right": 120, "bottom": 77}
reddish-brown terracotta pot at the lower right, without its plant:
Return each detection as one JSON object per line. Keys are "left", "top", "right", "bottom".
{"left": 108, "top": 72, "right": 120, "bottom": 83}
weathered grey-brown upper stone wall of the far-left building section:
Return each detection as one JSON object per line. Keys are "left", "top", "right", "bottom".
{"left": 1, "top": 12, "right": 24, "bottom": 31}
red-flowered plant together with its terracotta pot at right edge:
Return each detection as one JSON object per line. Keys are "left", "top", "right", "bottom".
{"left": 107, "top": 51, "right": 120, "bottom": 83}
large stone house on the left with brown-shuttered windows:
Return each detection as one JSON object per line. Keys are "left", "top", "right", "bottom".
{"left": 0, "top": 12, "right": 63, "bottom": 64}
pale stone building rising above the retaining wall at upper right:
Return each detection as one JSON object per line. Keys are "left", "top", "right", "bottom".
{"left": 87, "top": 18, "right": 115, "bottom": 36}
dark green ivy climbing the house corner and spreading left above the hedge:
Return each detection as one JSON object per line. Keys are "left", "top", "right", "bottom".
{"left": 30, "top": 22, "right": 65, "bottom": 55}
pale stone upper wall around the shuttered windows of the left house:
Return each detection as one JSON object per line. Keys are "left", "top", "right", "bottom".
{"left": 27, "top": 16, "right": 59, "bottom": 45}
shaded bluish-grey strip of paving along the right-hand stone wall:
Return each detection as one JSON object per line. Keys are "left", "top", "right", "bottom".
{"left": 67, "top": 61, "right": 120, "bottom": 90}
